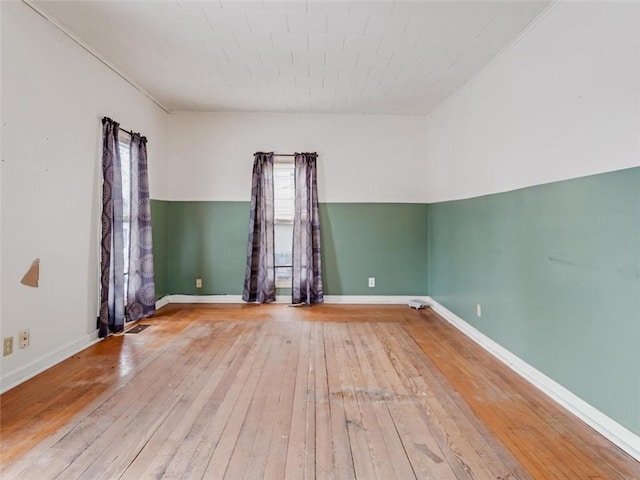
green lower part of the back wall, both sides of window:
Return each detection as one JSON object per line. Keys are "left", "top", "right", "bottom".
{"left": 152, "top": 200, "right": 427, "bottom": 295}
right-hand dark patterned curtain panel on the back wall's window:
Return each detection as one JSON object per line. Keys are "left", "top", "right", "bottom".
{"left": 291, "top": 153, "right": 324, "bottom": 304}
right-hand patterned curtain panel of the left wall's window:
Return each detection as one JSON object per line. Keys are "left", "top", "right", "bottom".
{"left": 127, "top": 133, "right": 156, "bottom": 321}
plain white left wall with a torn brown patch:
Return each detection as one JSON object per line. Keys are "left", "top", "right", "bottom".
{"left": 1, "top": 2, "right": 167, "bottom": 389}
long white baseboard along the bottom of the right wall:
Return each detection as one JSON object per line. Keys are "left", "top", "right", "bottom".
{"left": 428, "top": 298, "right": 640, "bottom": 461}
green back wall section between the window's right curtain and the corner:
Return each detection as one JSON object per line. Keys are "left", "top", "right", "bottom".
{"left": 320, "top": 203, "right": 427, "bottom": 296}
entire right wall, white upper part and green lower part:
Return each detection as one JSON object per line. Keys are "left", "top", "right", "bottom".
{"left": 427, "top": 2, "right": 640, "bottom": 442}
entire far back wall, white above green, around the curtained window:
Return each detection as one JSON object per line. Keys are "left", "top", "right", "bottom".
{"left": 153, "top": 113, "right": 427, "bottom": 296}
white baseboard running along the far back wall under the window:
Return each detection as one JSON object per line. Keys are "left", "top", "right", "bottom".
{"left": 156, "top": 295, "right": 428, "bottom": 308}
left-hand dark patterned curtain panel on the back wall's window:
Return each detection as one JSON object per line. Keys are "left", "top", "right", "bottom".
{"left": 242, "top": 152, "right": 276, "bottom": 303}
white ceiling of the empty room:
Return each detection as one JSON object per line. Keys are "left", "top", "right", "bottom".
{"left": 30, "top": 0, "right": 549, "bottom": 115}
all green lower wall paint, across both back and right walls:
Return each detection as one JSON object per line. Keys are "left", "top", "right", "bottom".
{"left": 152, "top": 168, "right": 640, "bottom": 434}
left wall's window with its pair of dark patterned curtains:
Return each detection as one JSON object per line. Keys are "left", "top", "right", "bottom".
{"left": 98, "top": 117, "right": 155, "bottom": 337}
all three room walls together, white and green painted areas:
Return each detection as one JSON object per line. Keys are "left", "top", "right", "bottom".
{"left": 0, "top": 2, "right": 640, "bottom": 460}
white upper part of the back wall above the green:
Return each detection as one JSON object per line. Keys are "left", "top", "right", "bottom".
{"left": 169, "top": 113, "right": 426, "bottom": 203}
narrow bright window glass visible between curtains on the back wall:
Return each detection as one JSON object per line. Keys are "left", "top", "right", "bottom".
{"left": 273, "top": 162, "right": 295, "bottom": 288}
